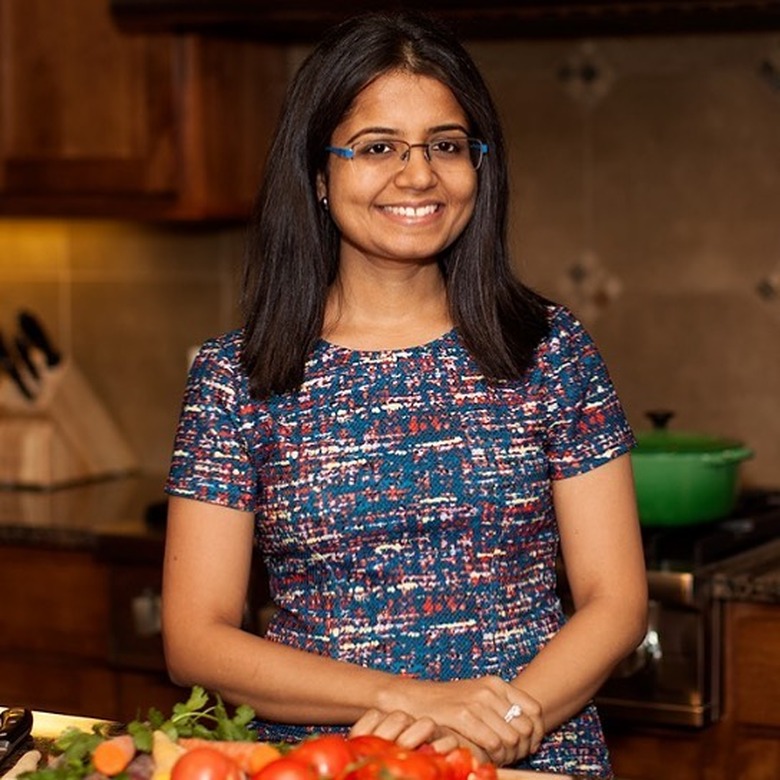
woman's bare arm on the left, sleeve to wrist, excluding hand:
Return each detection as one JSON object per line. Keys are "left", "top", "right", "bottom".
{"left": 163, "top": 497, "right": 396, "bottom": 723}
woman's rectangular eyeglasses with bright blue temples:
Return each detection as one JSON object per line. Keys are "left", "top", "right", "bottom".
{"left": 325, "top": 137, "right": 488, "bottom": 173}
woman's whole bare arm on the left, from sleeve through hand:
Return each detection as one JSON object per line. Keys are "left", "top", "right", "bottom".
{"left": 163, "top": 497, "right": 522, "bottom": 762}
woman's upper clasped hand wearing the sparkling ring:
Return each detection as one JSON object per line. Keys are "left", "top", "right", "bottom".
{"left": 382, "top": 676, "right": 544, "bottom": 766}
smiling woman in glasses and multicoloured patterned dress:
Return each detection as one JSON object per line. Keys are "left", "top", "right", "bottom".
{"left": 163, "top": 9, "right": 647, "bottom": 777}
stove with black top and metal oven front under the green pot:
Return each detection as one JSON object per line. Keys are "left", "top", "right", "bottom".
{"left": 596, "top": 490, "right": 780, "bottom": 728}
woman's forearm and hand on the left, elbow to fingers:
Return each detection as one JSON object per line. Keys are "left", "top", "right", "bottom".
{"left": 164, "top": 613, "right": 541, "bottom": 763}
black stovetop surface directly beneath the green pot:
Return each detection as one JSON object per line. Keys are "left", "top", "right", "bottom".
{"left": 642, "top": 490, "right": 780, "bottom": 571}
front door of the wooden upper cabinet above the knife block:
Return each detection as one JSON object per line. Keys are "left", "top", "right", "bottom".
{"left": 0, "top": 0, "right": 178, "bottom": 204}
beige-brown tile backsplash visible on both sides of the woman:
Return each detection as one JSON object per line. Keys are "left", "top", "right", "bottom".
{"left": 0, "top": 34, "right": 780, "bottom": 486}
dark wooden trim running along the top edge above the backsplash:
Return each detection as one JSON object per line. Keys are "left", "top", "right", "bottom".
{"left": 110, "top": 0, "right": 780, "bottom": 40}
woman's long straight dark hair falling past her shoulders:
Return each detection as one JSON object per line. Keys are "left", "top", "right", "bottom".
{"left": 242, "top": 12, "right": 548, "bottom": 398}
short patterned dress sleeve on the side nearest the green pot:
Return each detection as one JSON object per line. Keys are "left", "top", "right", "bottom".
{"left": 542, "top": 308, "right": 635, "bottom": 479}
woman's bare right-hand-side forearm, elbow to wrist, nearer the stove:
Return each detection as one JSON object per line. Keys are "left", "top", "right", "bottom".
{"left": 506, "top": 599, "right": 647, "bottom": 732}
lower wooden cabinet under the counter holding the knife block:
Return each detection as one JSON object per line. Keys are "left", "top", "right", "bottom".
{"left": 0, "top": 545, "right": 183, "bottom": 720}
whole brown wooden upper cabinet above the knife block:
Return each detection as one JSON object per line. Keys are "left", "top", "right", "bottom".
{"left": 0, "top": 0, "right": 285, "bottom": 219}
